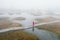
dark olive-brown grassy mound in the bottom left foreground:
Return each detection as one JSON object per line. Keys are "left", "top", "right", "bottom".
{"left": 0, "top": 30, "right": 39, "bottom": 40}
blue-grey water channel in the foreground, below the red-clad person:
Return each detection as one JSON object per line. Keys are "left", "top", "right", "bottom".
{"left": 25, "top": 28, "right": 59, "bottom": 40}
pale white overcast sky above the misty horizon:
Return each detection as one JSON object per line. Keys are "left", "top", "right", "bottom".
{"left": 0, "top": 0, "right": 60, "bottom": 10}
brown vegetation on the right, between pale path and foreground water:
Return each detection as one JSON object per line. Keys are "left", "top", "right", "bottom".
{"left": 38, "top": 22, "right": 60, "bottom": 39}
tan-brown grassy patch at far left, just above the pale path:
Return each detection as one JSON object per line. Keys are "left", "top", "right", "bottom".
{"left": 0, "top": 21, "right": 22, "bottom": 29}
